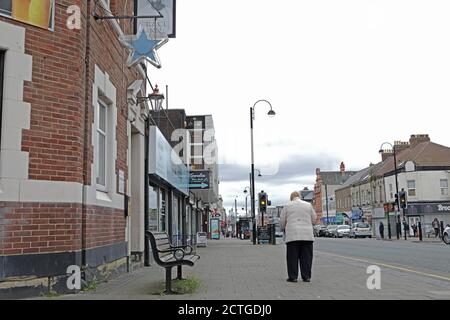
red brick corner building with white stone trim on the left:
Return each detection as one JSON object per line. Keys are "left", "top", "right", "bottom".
{"left": 0, "top": 0, "right": 151, "bottom": 297}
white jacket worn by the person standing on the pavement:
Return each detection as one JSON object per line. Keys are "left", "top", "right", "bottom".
{"left": 280, "top": 198, "right": 316, "bottom": 242}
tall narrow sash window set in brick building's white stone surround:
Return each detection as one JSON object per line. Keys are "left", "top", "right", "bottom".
{"left": 97, "top": 101, "right": 108, "bottom": 191}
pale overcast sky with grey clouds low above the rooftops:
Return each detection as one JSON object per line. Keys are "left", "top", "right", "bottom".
{"left": 150, "top": 0, "right": 450, "bottom": 210}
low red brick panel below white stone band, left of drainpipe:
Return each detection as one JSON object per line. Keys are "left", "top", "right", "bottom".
{"left": 0, "top": 202, "right": 81, "bottom": 255}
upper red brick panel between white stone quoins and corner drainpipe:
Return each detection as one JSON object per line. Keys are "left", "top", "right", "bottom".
{"left": 11, "top": 0, "right": 85, "bottom": 182}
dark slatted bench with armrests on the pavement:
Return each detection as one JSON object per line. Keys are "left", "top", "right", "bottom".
{"left": 146, "top": 231, "right": 200, "bottom": 294}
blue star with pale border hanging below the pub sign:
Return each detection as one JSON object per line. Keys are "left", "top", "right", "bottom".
{"left": 119, "top": 27, "right": 169, "bottom": 68}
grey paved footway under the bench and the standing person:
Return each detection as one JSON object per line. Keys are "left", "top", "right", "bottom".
{"left": 35, "top": 239, "right": 450, "bottom": 300}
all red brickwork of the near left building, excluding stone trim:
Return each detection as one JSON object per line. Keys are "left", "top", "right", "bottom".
{"left": 0, "top": 0, "right": 137, "bottom": 264}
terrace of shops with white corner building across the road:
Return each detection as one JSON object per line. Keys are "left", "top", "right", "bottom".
{"left": 336, "top": 134, "right": 450, "bottom": 235}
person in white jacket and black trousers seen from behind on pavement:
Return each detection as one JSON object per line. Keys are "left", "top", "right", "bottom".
{"left": 280, "top": 191, "right": 316, "bottom": 282}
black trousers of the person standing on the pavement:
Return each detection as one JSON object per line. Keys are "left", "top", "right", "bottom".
{"left": 286, "top": 241, "right": 314, "bottom": 279}
